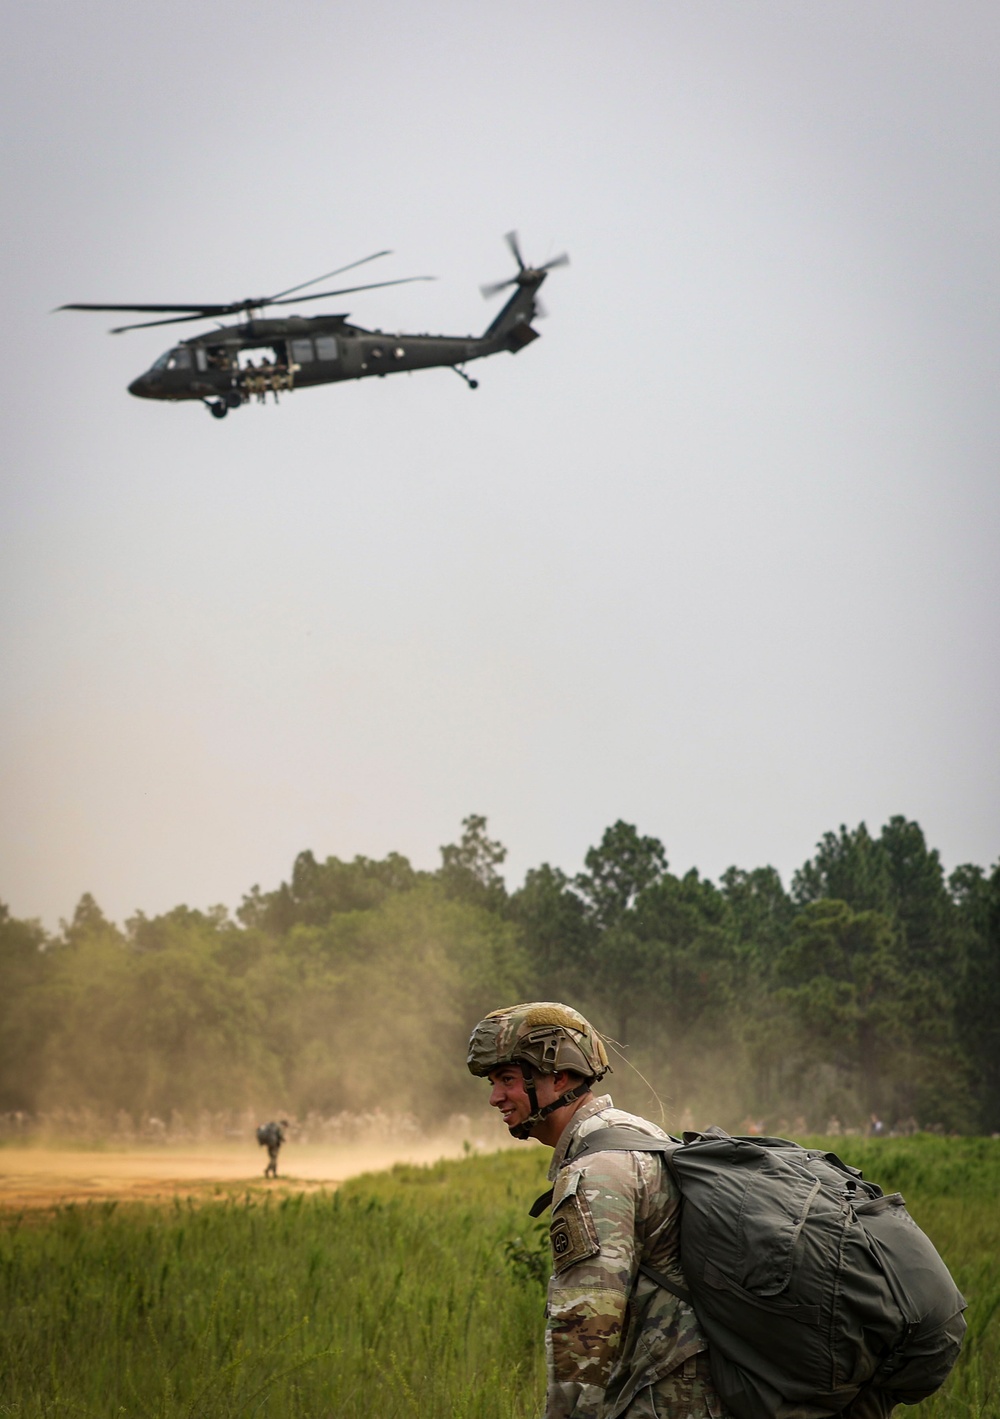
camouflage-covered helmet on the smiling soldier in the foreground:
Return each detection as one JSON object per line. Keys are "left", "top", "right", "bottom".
{"left": 467, "top": 1000, "right": 611, "bottom": 1080}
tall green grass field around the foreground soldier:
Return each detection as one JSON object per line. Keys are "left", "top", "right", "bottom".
{"left": 0, "top": 1137, "right": 1000, "bottom": 1419}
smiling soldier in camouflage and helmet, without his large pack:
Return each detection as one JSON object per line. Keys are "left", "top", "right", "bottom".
{"left": 468, "top": 1002, "right": 729, "bottom": 1419}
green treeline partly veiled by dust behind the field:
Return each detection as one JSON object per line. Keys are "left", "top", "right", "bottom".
{"left": 0, "top": 816, "right": 1000, "bottom": 1132}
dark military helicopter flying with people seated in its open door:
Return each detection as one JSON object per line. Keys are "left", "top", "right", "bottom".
{"left": 58, "top": 231, "right": 569, "bottom": 419}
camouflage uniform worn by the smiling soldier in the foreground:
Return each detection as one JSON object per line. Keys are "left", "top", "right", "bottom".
{"left": 545, "top": 1094, "right": 726, "bottom": 1419}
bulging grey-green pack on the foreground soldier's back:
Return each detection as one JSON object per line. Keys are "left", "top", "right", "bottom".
{"left": 564, "top": 1125, "right": 966, "bottom": 1419}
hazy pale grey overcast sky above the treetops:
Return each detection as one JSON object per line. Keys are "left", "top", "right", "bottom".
{"left": 0, "top": 0, "right": 1000, "bottom": 925}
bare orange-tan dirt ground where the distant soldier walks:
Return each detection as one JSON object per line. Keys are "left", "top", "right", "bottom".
{"left": 0, "top": 1139, "right": 482, "bottom": 1212}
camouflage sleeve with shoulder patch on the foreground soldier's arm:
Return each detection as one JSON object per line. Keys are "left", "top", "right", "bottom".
{"left": 545, "top": 1152, "right": 641, "bottom": 1419}
